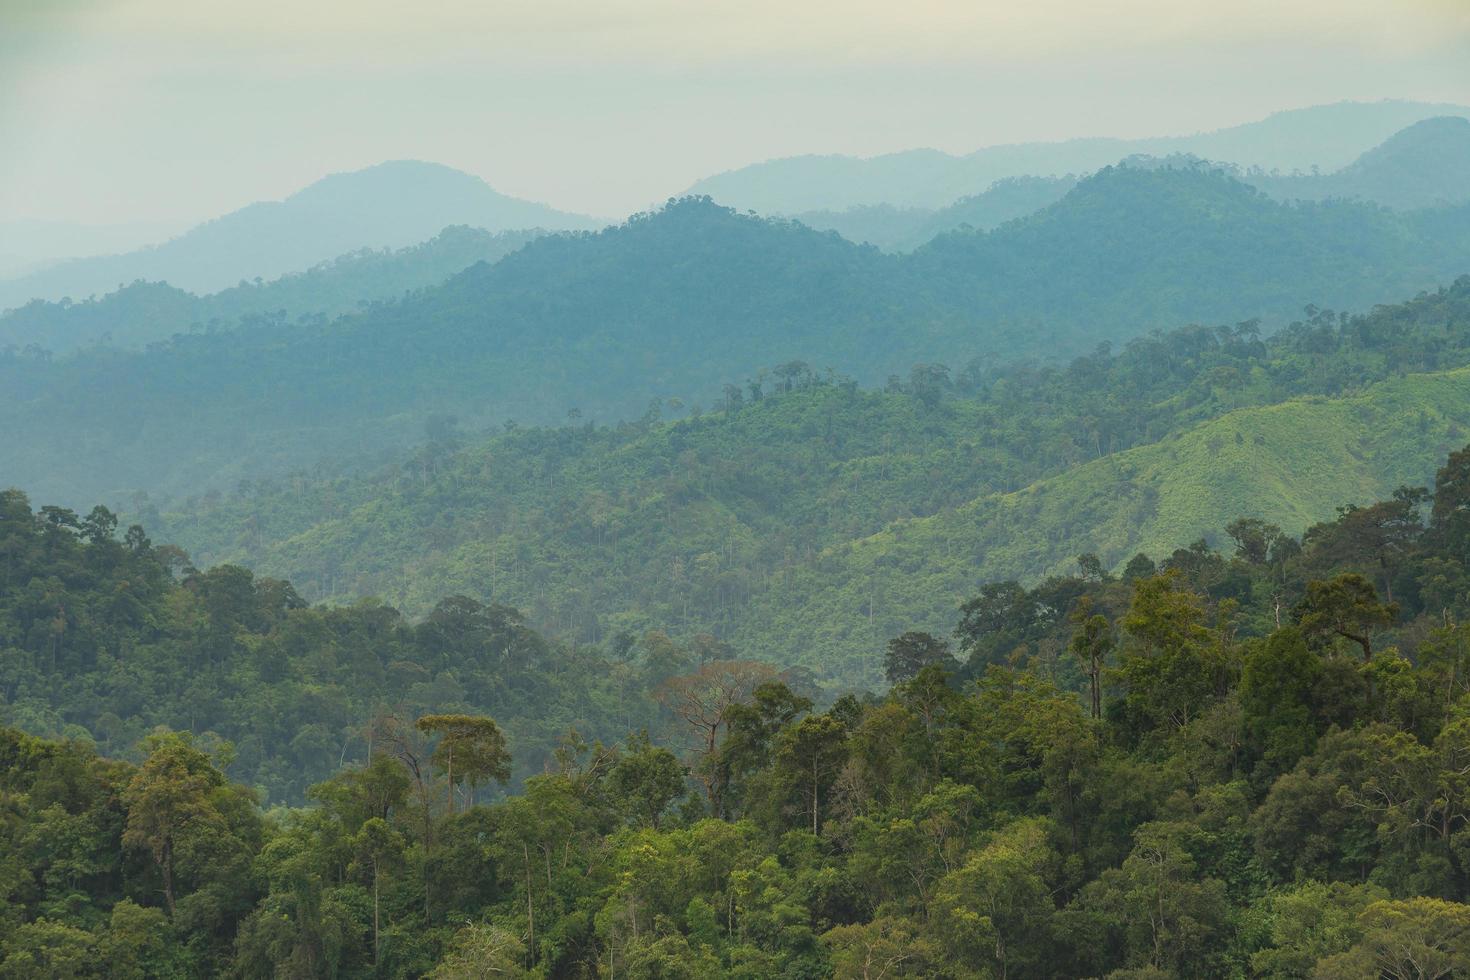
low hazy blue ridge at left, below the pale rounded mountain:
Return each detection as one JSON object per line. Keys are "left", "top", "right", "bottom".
{"left": 0, "top": 225, "right": 547, "bottom": 354}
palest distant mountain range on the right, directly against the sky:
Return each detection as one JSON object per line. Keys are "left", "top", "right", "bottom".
{"left": 688, "top": 101, "right": 1470, "bottom": 215}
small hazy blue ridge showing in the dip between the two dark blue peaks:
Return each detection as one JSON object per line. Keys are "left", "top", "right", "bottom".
{"left": 795, "top": 176, "right": 1078, "bottom": 251}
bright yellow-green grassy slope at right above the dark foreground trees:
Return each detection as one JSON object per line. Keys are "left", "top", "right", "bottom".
{"left": 734, "top": 369, "right": 1470, "bottom": 679}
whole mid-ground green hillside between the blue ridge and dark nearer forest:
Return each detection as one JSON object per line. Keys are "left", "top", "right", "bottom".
{"left": 143, "top": 279, "right": 1470, "bottom": 683}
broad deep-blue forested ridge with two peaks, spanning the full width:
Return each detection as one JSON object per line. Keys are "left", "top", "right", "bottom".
{"left": 0, "top": 167, "right": 1470, "bottom": 511}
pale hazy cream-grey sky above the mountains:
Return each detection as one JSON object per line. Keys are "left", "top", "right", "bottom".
{"left": 0, "top": 0, "right": 1470, "bottom": 222}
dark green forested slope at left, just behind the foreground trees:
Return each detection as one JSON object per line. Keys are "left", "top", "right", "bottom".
{"left": 0, "top": 491, "right": 746, "bottom": 802}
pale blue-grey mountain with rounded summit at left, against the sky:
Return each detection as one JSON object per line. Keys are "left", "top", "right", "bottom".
{"left": 0, "top": 160, "right": 598, "bottom": 309}
